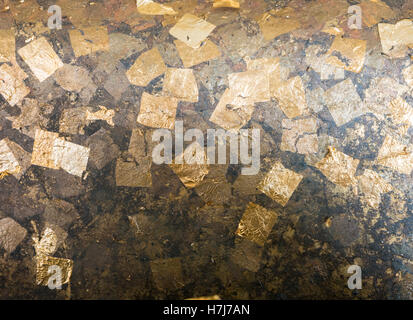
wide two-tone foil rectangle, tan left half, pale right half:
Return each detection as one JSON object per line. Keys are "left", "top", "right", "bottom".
{"left": 31, "top": 129, "right": 90, "bottom": 177}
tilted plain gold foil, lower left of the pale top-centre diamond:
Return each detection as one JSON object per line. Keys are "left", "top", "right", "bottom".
{"left": 126, "top": 47, "right": 166, "bottom": 87}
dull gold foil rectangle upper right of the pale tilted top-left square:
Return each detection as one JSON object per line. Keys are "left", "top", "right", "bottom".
{"left": 69, "top": 26, "right": 109, "bottom": 57}
